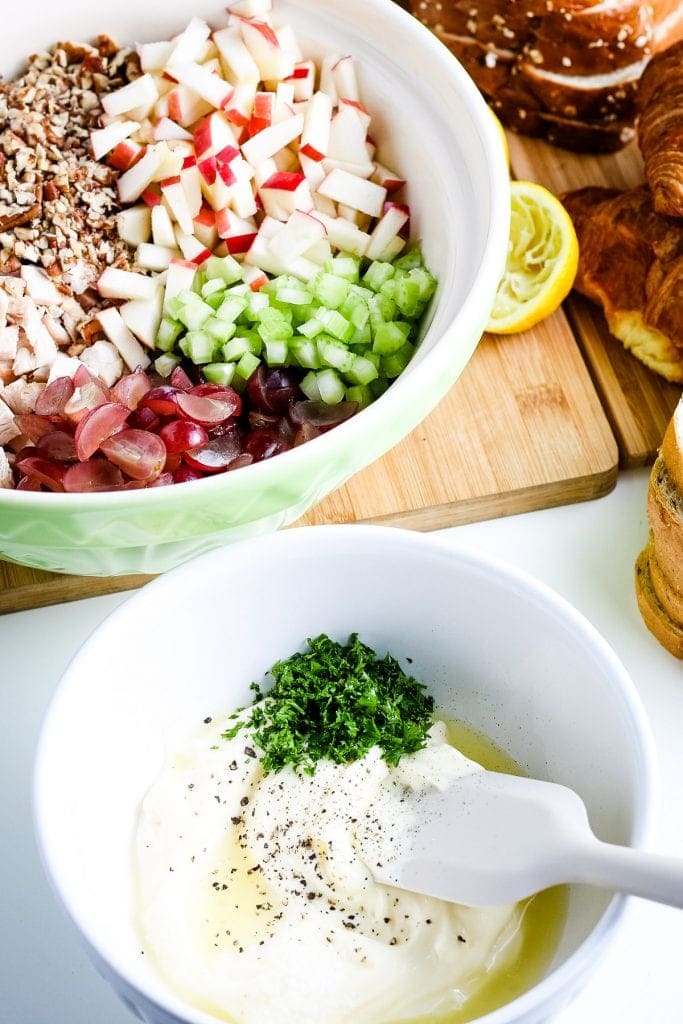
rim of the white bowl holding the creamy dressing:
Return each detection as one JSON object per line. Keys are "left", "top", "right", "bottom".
{"left": 32, "top": 524, "right": 660, "bottom": 1024}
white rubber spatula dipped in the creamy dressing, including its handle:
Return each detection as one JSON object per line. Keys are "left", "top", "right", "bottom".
{"left": 371, "top": 771, "right": 683, "bottom": 907}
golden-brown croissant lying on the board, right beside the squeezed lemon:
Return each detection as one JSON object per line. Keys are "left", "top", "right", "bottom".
{"left": 560, "top": 184, "right": 683, "bottom": 384}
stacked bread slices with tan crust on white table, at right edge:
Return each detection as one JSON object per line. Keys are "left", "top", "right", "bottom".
{"left": 636, "top": 398, "right": 683, "bottom": 658}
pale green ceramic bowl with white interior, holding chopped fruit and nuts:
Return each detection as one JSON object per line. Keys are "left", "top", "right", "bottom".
{"left": 0, "top": 0, "right": 509, "bottom": 575}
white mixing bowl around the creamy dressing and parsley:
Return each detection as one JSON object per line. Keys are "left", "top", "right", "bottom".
{"left": 35, "top": 526, "right": 654, "bottom": 1024}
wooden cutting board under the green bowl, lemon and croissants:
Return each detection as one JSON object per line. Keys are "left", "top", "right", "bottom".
{"left": 0, "top": 124, "right": 680, "bottom": 612}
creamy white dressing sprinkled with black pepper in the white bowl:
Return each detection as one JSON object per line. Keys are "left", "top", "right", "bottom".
{"left": 136, "top": 717, "right": 565, "bottom": 1024}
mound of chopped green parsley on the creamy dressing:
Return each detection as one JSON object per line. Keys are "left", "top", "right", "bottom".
{"left": 222, "top": 633, "right": 434, "bottom": 775}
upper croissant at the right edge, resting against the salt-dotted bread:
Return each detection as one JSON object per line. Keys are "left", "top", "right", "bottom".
{"left": 638, "top": 40, "right": 683, "bottom": 217}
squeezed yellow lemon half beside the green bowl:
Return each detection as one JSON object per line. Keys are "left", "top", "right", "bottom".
{"left": 486, "top": 181, "right": 579, "bottom": 334}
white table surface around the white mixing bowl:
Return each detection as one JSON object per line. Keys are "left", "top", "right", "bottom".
{"left": 0, "top": 470, "right": 683, "bottom": 1024}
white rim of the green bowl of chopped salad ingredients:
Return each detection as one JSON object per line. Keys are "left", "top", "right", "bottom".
{"left": 0, "top": 0, "right": 510, "bottom": 513}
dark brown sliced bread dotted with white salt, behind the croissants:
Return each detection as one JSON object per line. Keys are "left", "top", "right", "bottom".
{"left": 412, "top": 0, "right": 683, "bottom": 153}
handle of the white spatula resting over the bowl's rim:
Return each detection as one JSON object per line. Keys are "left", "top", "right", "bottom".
{"left": 572, "top": 841, "right": 683, "bottom": 908}
